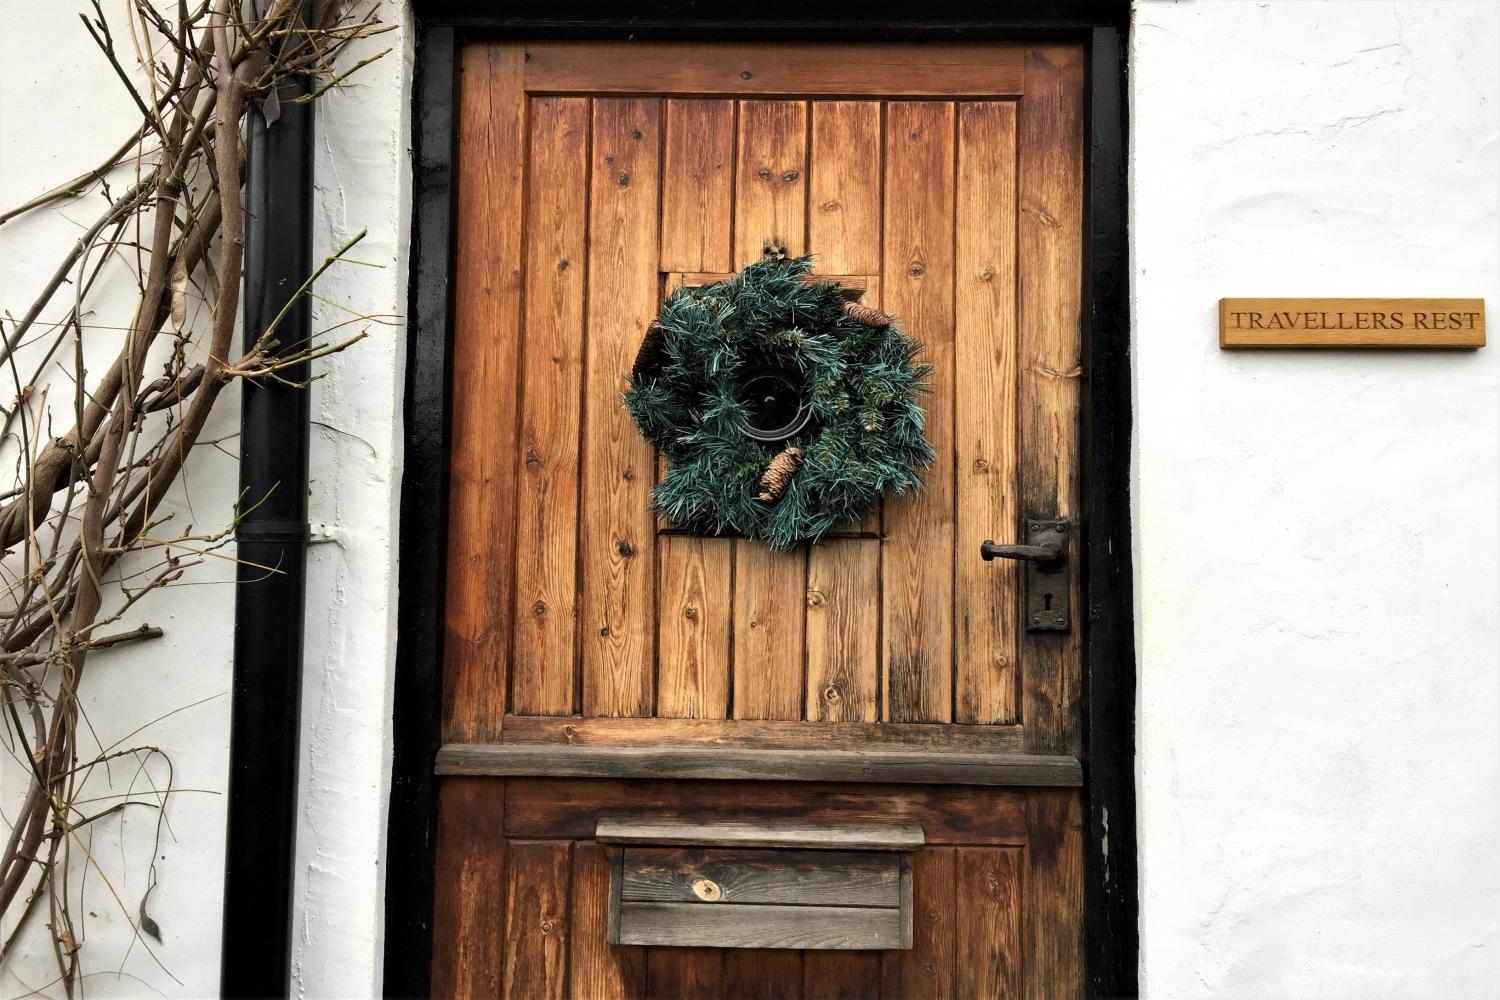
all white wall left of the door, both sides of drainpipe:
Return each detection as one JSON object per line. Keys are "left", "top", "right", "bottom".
{"left": 0, "top": 0, "right": 414, "bottom": 997}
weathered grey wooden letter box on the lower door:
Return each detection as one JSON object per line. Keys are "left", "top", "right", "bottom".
{"left": 594, "top": 819, "right": 924, "bottom": 951}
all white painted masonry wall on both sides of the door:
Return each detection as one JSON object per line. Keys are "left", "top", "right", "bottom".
{"left": 0, "top": 0, "right": 1500, "bottom": 1000}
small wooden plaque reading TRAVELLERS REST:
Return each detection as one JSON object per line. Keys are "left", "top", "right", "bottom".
{"left": 1220, "top": 298, "right": 1485, "bottom": 348}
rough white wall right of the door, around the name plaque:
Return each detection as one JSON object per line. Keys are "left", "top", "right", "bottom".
{"left": 1131, "top": 0, "right": 1500, "bottom": 1000}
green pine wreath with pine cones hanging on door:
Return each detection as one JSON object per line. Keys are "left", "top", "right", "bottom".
{"left": 626, "top": 253, "right": 933, "bottom": 549}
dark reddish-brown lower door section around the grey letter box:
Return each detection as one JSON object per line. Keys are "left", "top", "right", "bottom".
{"left": 434, "top": 778, "right": 1082, "bottom": 1000}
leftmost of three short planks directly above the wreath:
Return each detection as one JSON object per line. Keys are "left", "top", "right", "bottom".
{"left": 662, "top": 100, "right": 735, "bottom": 271}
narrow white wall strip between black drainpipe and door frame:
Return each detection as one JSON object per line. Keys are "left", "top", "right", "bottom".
{"left": 293, "top": 0, "right": 416, "bottom": 997}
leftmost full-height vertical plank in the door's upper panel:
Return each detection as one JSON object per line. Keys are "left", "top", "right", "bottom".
{"left": 510, "top": 97, "right": 590, "bottom": 715}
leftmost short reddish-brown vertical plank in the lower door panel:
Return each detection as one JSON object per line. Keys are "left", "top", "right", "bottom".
{"left": 504, "top": 841, "right": 569, "bottom": 1000}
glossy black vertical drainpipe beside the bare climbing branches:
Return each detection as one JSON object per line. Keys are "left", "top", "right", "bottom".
{"left": 219, "top": 0, "right": 314, "bottom": 997}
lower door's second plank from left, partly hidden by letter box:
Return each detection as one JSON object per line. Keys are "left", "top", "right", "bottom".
{"left": 569, "top": 843, "right": 647, "bottom": 1000}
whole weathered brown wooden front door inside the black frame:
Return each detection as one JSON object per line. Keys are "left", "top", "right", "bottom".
{"left": 434, "top": 43, "right": 1083, "bottom": 1000}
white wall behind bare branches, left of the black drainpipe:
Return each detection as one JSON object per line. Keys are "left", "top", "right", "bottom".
{"left": 0, "top": 0, "right": 239, "bottom": 999}
